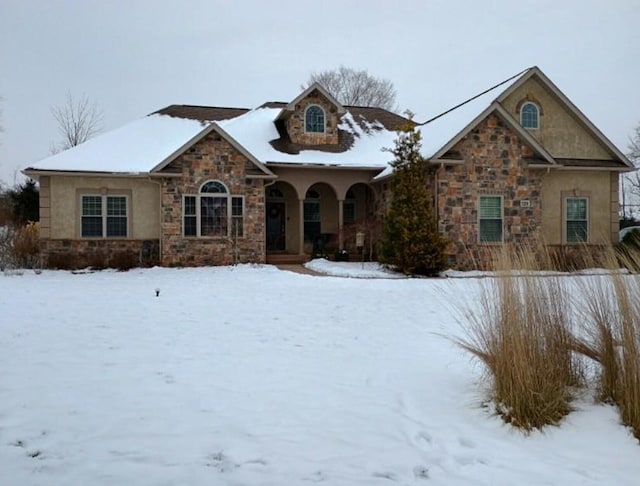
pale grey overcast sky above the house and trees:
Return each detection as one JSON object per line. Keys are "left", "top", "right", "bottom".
{"left": 0, "top": 0, "right": 640, "bottom": 184}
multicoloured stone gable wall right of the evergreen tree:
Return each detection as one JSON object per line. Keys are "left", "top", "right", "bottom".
{"left": 436, "top": 115, "right": 544, "bottom": 268}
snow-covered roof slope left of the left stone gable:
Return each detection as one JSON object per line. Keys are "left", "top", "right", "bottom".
{"left": 27, "top": 114, "right": 205, "bottom": 174}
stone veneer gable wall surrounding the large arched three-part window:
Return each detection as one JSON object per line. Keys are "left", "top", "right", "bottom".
{"left": 161, "top": 132, "right": 265, "bottom": 266}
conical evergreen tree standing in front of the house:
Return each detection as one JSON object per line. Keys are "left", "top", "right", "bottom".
{"left": 380, "top": 121, "right": 446, "bottom": 275}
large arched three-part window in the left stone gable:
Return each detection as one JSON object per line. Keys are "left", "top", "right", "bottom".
{"left": 182, "top": 181, "right": 244, "bottom": 237}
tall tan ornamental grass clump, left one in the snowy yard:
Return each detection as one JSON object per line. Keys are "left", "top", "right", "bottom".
{"left": 458, "top": 248, "right": 583, "bottom": 431}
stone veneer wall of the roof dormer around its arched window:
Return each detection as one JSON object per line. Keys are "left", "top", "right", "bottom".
{"left": 287, "top": 90, "right": 338, "bottom": 145}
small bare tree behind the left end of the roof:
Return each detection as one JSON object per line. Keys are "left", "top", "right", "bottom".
{"left": 51, "top": 92, "right": 103, "bottom": 153}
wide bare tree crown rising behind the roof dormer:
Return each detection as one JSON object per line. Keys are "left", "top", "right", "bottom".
{"left": 302, "top": 66, "right": 396, "bottom": 111}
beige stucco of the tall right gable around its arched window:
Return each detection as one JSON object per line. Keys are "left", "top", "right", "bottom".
{"left": 502, "top": 78, "right": 612, "bottom": 160}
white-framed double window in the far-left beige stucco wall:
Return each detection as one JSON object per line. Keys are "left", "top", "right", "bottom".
{"left": 80, "top": 195, "right": 129, "bottom": 238}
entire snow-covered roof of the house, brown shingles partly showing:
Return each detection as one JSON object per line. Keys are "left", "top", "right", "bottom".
{"left": 25, "top": 67, "right": 631, "bottom": 179}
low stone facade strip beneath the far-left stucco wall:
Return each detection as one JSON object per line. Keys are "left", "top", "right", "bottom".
{"left": 40, "top": 238, "right": 160, "bottom": 269}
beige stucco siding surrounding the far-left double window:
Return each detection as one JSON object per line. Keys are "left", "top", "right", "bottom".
{"left": 49, "top": 176, "right": 160, "bottom": 239}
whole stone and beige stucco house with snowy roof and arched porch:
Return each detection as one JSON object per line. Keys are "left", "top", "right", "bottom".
{"left": 23, "top": 67, "right": 632, "bottom": 266}
